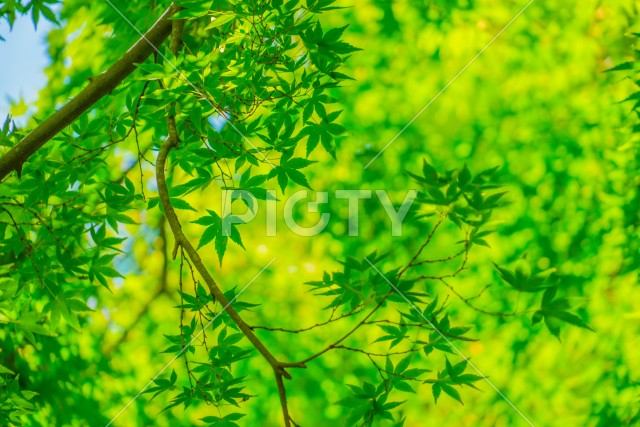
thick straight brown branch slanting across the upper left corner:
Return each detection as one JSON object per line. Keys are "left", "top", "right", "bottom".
{"left": 0, "top": 3, "right": 180, "bottom": 181}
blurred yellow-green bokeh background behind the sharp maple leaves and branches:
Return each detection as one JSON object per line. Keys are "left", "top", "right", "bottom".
{"left": 0, "top": 0, "right": 640, "bottom": 427}
